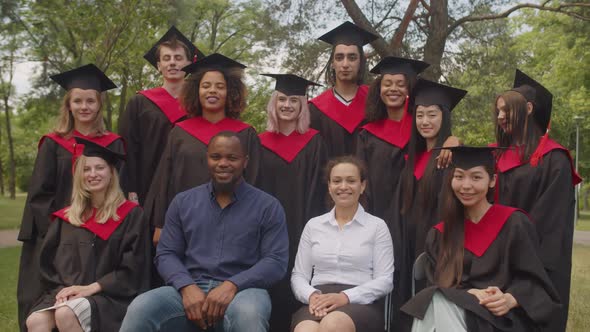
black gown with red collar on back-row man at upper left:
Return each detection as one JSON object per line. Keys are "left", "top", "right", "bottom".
{"left": 119, "top": 88, "right": 186, "bottom": 206}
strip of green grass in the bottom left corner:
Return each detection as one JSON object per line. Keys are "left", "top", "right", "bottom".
{"left": 0, "top": 246, "right": 21, "bottom": 332}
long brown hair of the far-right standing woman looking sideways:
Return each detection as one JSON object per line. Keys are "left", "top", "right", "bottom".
{"left": 494, "top": 91, "right": 543, "bottom": 162}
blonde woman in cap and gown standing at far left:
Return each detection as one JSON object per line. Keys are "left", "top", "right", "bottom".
{"left": 17, "top": 64, "right": 125, "bottom": 330}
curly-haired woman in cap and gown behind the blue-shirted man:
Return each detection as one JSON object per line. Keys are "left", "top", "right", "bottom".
{"left": 145, "top": 53, "right": 260, "bottom": 243}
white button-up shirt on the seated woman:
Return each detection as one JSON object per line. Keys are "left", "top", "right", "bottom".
{"left": 291, "top": 205, "right": 393, "bottom": 304}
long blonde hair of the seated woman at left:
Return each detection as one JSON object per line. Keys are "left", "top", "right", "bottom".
{"left": 66, "top": 155, "right": 125, "bottom": 226}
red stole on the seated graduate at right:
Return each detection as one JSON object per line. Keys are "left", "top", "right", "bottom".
{"left": 434, "top": 204, "right": 524, "bottom": 257}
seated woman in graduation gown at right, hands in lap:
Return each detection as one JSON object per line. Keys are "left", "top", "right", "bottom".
{"left": 402, "top": 147, "right": 560, "bottom": 332}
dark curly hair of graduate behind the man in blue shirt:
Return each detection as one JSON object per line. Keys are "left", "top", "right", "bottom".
{"left": 179, "top": 68, "right": 248, "bottom": 119}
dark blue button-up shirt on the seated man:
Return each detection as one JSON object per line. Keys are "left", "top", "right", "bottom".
{"left": 154, "top": 181, "right": 289, "bottom": 290}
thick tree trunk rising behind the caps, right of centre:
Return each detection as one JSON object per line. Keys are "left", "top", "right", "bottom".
{"left": 423, "top": 0, "right": 449, "bottom": 81}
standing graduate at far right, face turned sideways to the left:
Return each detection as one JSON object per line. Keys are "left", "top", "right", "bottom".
{"left": 495, "top": 70, "right": 582, "bottom": 332}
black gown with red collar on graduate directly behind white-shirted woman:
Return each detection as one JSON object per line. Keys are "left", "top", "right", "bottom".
{"left": 309, "top": 85, "right": 368, "bottom": 159}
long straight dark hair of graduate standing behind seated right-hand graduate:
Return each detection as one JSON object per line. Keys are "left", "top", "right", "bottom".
{"left": 401, "top": 105, "right": 451, "bottom": 217}
